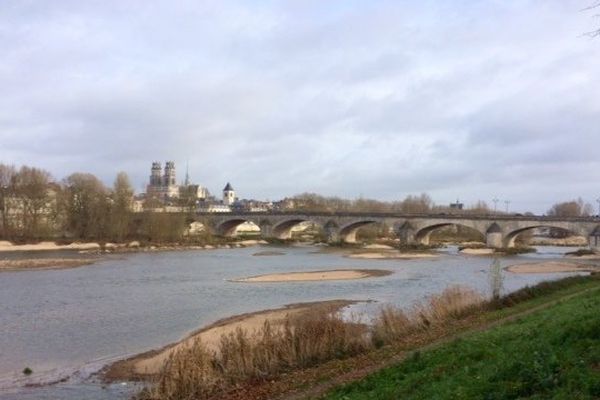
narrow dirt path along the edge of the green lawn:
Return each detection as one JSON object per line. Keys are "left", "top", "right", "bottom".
{"left": 274, "top": 287, "right": 600, "bottom": 400}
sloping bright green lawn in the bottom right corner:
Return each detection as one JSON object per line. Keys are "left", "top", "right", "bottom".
{"left": 324, "top": 285, "right": 600, "bottom": 400}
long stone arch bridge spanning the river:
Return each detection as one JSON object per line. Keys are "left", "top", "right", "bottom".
{"left": 196, "top": 211, "right": 600, "bottom": 249}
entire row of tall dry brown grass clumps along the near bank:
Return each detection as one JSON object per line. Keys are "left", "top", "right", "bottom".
{"left": 138, "top": 287, "right": 484, "bottom": 400}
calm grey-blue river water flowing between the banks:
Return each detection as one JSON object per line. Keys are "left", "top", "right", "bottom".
{"left": 0, "top": 247, "right": 584, "bottom": 400}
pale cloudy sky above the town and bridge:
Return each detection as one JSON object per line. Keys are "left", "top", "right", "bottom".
{"left": 0, "top": 0, "right": 600, "bottom": 213}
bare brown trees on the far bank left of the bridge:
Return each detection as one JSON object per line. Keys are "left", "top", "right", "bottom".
{"left": 0, "top": 163, "right": 196, "bottom": 242}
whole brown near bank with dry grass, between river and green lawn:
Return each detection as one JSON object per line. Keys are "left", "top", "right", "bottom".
{"left": 131, "top": 276, "right": 600, "bottom": 400}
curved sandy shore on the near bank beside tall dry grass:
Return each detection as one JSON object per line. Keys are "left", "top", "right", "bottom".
{"left": 102, "top": 300, "right": 355, "bottom": 382}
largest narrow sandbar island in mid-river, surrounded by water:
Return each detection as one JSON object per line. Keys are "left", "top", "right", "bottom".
{"left": 232, "top": 269, "right": 392, "bottom": 282}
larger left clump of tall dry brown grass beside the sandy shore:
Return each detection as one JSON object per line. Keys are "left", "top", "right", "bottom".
{"left": 138, "top": 309, "right": 371, "bottom": 400}
